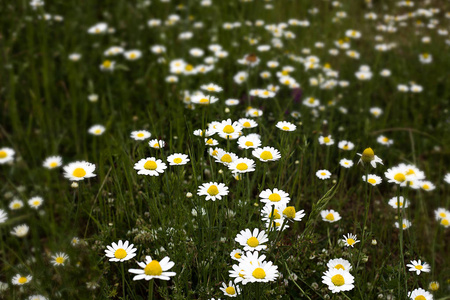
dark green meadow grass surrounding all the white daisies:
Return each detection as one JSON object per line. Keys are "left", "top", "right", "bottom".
{"left": 0, "top": 0, "right": 450, "bottom": 299}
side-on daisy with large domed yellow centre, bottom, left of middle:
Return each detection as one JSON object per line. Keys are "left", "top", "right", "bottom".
{"left": 128, "top": 255, "right": 176, "bottom": 280}
